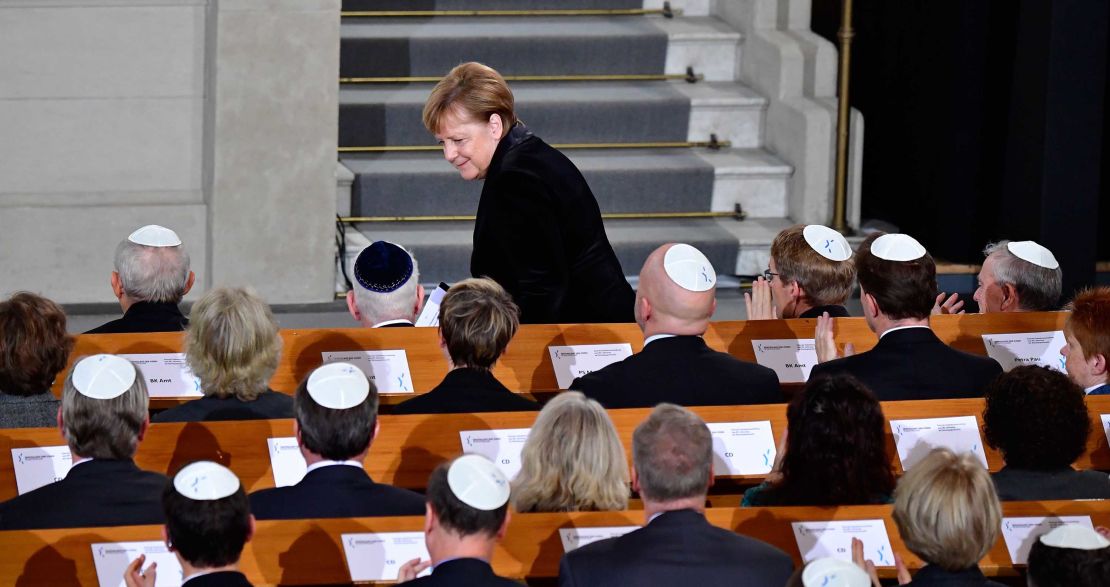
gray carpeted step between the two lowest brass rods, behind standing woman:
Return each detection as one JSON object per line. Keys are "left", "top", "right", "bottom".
{"left": 343, "top": 149, "right": 714, "bottom": 216}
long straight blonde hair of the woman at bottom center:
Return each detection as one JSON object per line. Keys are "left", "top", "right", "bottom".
{"left": 512, "top": 392, "right": 628, "bottom": 512}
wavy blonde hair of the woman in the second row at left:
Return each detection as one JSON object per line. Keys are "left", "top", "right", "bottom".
{"left": 184, "top": 287, "right": 282, "bottom": 402}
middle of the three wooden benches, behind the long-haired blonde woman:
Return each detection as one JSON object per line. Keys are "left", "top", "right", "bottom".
{"left": 0, "top": 396, "right": 1110, "bottom": 499}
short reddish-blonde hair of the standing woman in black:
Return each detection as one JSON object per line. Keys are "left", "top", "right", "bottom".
{"left": 424, "top": 61, "right": 516, "bottom": 134}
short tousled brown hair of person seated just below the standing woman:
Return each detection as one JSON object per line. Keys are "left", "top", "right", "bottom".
{"left": 440, "top": 277, "right": 521, "bottom": 370}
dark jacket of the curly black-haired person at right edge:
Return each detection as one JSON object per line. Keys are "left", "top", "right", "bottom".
{"left": 990, "top": 466, "right": 1110, "bottom": 502}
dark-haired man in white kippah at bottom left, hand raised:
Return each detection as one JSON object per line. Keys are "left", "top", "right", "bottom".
{"left": 123, "top": 461, "right": 254, "bottom": 587}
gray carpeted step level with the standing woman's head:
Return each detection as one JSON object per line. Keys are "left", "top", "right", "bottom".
{"left": 339, "top": 82, "right": 688, "bottom": 146}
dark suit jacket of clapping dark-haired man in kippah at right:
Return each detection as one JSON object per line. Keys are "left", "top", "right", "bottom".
{"left": 809, "top": 328, "right": 1002, "bottom": 402}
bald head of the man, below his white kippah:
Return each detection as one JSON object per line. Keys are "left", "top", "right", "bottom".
{"left": 636, "top": 243, "right": 717, "bottom": 336}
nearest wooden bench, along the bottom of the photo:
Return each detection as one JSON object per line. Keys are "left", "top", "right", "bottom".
{"left": 0, "top": 502, "right": 1110, "bottom": 586}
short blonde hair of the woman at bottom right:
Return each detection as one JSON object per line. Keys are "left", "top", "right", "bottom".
{"left": 894, "top": 448, "right": 1002, "bottom": 570}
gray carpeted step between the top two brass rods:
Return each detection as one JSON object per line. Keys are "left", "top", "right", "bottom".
{"left": 340, "top": 17, "right": 667, "bottom": 78}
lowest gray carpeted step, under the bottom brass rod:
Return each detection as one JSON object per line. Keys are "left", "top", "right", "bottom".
{"left": 356, "top": 219, "right": 739, "bottom": 283}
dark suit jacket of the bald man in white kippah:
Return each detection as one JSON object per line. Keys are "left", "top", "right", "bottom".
{"left": 571, "top": 336, "right": 785, "bottom": 408}
